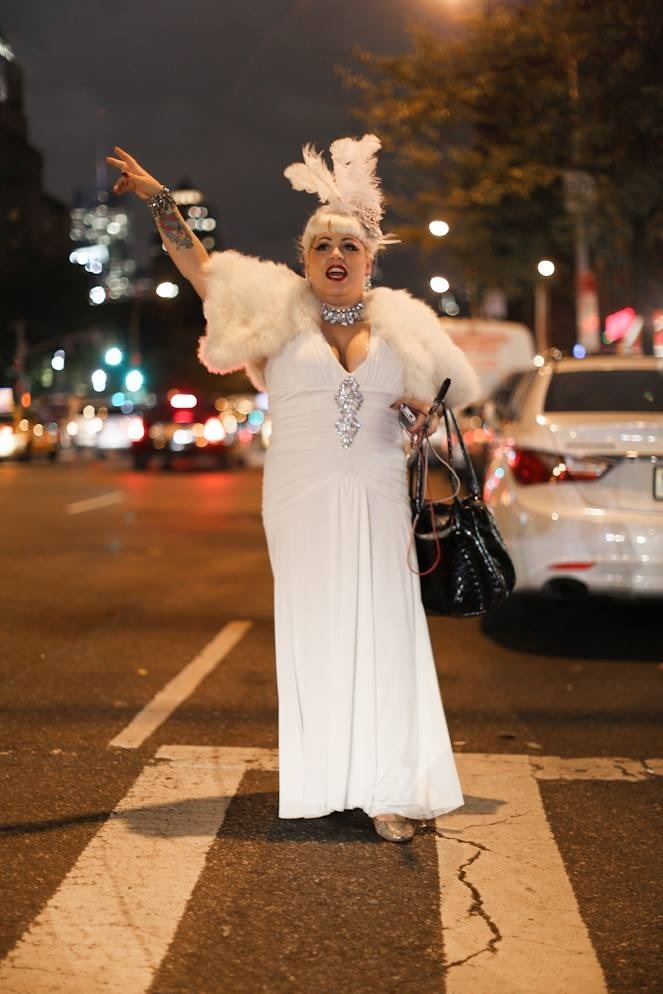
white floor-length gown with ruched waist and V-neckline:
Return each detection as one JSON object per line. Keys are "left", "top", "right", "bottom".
{"left": 263, "top": 322, "right": 463, "bottom": 818}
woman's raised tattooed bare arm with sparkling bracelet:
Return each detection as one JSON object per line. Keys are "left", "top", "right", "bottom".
{"left": 106, "top": 145, "right": 209, "bottom": 298}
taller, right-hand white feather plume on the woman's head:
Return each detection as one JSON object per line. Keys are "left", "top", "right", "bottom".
{"left": 329, "top": 135, "right": 383, "bottom": 226}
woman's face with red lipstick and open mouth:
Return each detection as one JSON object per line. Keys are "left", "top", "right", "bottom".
{"left": 306, "top": 231, "right": 372, "bottom": 307}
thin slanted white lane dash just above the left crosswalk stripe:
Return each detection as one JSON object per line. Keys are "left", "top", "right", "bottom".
{"left": 108, "top": 621, "right": 253, "bottom": 749}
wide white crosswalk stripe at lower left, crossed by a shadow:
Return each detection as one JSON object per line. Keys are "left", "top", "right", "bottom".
{"left": 0, "top": 750, "right": 243, "bottom": 994}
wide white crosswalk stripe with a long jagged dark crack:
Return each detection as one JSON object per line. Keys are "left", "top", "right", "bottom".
{"left": 436, "top": 753, "right": 608, "bottom": 994}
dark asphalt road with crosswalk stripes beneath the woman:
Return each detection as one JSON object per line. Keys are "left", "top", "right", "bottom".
{"left": 0, "top": 452, "right": 663, "bottom": 994}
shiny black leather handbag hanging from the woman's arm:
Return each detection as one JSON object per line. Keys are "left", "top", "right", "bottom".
{"left": 410, "top": 379, "right": 516, "bottom": 618}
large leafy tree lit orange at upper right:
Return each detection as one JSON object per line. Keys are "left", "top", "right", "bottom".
{"left": 341, "top": 0, "right": 663, "bottom": 338}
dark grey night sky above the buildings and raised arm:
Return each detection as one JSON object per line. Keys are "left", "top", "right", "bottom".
{"left": 0, "top": 0, "right": 453, "bottom": 263}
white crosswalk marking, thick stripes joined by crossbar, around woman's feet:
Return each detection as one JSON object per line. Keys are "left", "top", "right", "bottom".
{"left": 0, "top": 745, "right": 663, "bottom": 994}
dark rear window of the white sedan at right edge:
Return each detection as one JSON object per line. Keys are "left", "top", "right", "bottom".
{"left": 544, "top": 369, "right": 663, "bottom": 412}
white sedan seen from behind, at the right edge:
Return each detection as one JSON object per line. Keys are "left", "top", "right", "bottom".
{"left": 484, "top": 356, "right": 663, "bottom": 596}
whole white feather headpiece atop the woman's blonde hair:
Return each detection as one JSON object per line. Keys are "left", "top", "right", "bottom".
{"left": 284, "top": 135, "right": 397, "bottom": 244}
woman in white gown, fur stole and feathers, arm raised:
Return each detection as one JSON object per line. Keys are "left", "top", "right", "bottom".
{"left": 108, "top": 136, "right": 476, "bottom": 842}
